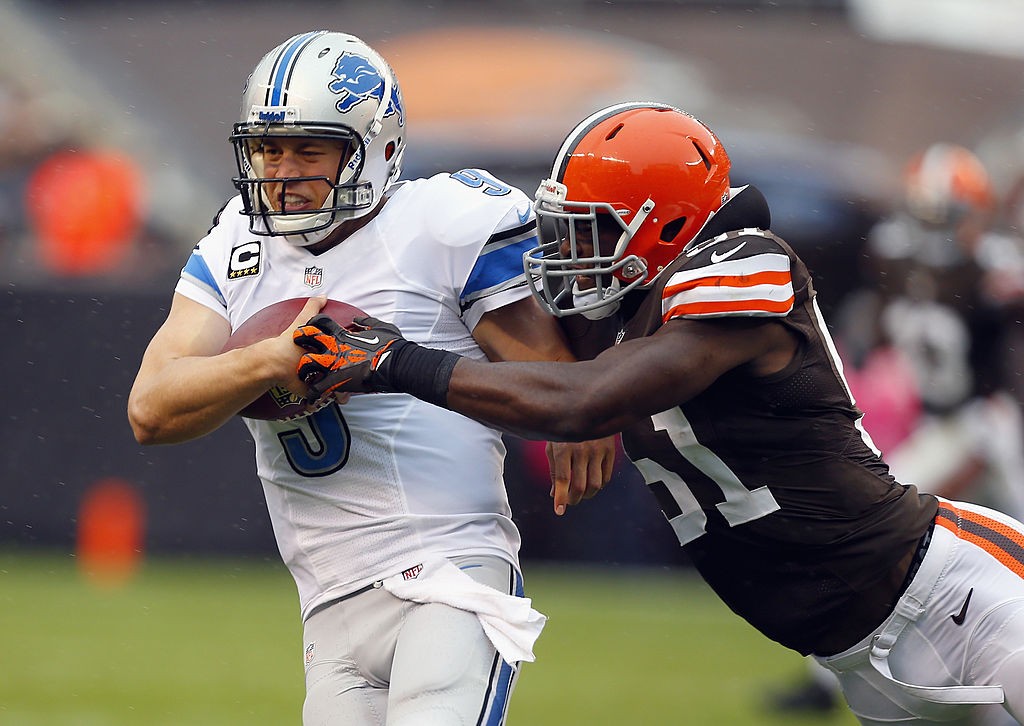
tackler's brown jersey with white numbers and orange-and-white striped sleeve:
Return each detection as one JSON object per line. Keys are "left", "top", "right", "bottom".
{"left": 569, "top": 214, "right": 936, "bottom": 654}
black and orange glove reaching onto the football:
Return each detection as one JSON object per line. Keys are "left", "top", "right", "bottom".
{"left": 292, "top": 315, "right": 407, "bottom": 400}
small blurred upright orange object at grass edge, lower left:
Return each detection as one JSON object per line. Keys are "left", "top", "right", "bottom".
{"left": 77, "top": 478, "right": 145, "bottom": 585}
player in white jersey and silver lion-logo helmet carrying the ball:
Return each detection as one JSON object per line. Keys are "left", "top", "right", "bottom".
{"left": 128, "top": 31, "right": 614, "bottom": 726}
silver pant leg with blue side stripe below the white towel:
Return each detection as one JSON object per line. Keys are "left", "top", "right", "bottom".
{"left": 388, "top": 556, "right": 523, "bottom": 726}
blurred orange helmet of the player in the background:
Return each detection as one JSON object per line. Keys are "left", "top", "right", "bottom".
{"left": 903, "top": 143, "right": 995, "bottom": 224}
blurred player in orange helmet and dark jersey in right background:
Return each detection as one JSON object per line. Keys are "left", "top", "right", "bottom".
{"left": 773, "top": 143, "right": 1024, "bottom": 718}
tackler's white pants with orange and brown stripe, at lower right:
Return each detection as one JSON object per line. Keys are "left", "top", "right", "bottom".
{"left": 817, "top": 500, "right": 1024, "bottom": 726}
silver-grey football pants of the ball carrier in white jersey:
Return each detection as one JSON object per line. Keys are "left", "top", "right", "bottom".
{"left": 302, "top": 556, "right": 523, "bottom": 726}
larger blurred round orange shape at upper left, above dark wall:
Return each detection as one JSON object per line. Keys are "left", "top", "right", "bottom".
{"left": 26, "top": 150, "right": 142, "bottom": 275}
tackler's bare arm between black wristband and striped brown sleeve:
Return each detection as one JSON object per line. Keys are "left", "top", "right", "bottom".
{"left": 447, "top": 319, "right": 797, "bottom": 441}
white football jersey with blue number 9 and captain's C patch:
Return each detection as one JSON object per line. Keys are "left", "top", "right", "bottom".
{"left": 176, "top": 170, "right": 537, "bottom": 617}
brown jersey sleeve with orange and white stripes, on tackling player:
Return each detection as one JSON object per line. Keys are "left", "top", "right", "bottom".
{"left": 662, "top": 230, "right": 795, "bottom": 323}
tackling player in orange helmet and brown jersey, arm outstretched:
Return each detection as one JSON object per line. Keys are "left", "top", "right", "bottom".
{"left": 295, "top": 102, "right": 1024, "bottom": 724}
